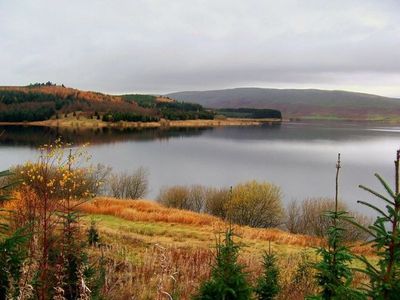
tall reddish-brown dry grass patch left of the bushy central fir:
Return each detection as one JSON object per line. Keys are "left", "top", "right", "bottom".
{"left": 93, "top": 245, "right": 213, "bottom": 300}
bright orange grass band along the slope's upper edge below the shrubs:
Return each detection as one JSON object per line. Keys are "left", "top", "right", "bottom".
{"left": 80, "top": 198, "right": 373, "bottom": 255}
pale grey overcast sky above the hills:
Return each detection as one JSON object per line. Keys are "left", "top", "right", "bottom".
{"left": 0, "top": 0, "right": 400, "bottom": 97}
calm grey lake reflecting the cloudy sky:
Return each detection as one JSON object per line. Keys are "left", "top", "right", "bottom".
{"left": 0, "top": 122, "right": 400, "bottom": 216}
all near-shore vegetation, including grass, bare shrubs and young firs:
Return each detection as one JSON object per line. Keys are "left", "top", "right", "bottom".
{"left": 0, "top": 142, "right": 400, "bottom": 299}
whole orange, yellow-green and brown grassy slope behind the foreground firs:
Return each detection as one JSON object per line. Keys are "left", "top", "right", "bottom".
{"left": 77, "top": 198, "right": 369, "bottom": 299}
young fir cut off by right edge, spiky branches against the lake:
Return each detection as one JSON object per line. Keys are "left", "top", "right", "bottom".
{"left": 353, "top": 150, "right": 400, "bottom": 300}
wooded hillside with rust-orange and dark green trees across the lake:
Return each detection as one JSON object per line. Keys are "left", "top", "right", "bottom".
{"left": 0, "top": 82, "right": 214, "bottom": 123}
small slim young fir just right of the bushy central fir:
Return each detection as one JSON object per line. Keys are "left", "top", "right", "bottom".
{"left": 255, "top": 244, "right": 280, "bottom": 300}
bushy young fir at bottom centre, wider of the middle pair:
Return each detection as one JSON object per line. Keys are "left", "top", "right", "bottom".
{"left": 194, "top": 228, "right": 251, "bottom": 300}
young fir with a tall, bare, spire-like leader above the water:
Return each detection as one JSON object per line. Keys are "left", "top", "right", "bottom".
{"left": 308, "top": 154, "right": 365, "bottom": 300}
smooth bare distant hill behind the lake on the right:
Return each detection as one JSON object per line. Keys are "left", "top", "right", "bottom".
{"left": 167, "top": 88, "right": 400, "bottom": 120}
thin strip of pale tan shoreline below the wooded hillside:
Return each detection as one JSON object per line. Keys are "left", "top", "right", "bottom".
{"left": 0, "top": 118, "right": 282, "bottom": 128}
